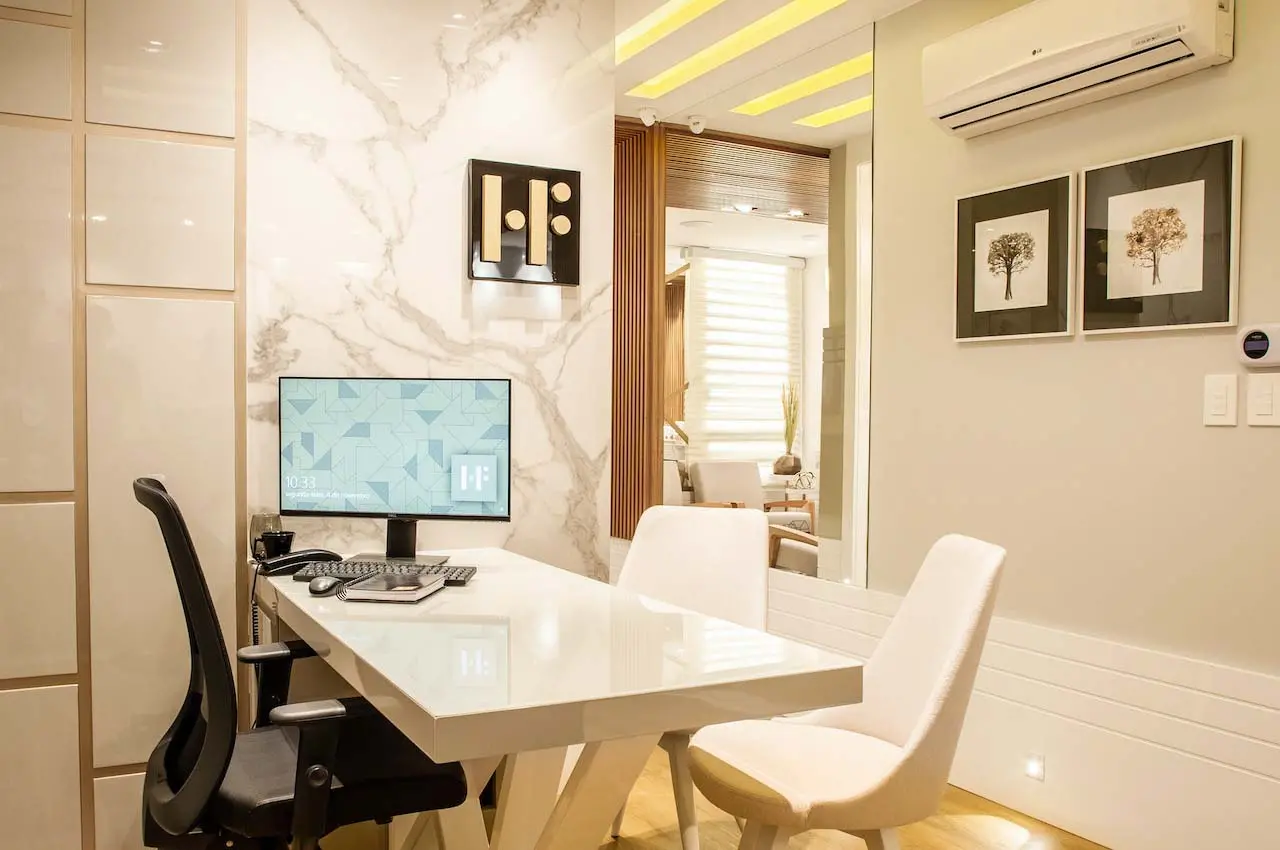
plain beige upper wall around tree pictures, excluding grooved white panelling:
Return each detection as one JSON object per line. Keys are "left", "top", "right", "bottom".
{"left": 870, "top": 0, "right": 1280, "bottom": 673}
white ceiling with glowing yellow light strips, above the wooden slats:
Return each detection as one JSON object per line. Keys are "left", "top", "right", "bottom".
{"left": 614, "top": 0, "right": 915, "bottom": 148}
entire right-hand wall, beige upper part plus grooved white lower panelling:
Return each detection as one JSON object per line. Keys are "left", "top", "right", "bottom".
{"left": 798, "top": 0, "right": 1280, "bottom": 850}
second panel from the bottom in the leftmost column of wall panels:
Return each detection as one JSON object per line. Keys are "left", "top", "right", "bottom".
{"left": 0, "top": 502, "right": 76, "bottom": 678}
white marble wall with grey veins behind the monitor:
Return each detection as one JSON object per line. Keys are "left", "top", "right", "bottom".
{"left": 247, "top": 0, "right": 613, "bottom": 577}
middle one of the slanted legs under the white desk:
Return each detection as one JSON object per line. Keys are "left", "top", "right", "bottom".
{"left": 490, "top": 746, "right": 564, "bottom": 850}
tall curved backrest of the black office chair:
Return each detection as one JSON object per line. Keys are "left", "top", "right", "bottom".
{"left": 133, "top": 479, "right": 236, "bottom": 835}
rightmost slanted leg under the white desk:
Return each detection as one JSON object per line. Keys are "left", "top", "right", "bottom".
{"left": 535, "top": 735, "right": 660, "bottom": 850}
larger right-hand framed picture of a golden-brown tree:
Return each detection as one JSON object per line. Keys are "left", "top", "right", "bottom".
{"left": 1080, "top": 138, "right": 1240, "bottom": 334}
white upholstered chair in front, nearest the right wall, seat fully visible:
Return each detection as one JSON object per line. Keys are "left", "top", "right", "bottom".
{"left": 690, "top": 535, "right": 1005, "bottom": 850}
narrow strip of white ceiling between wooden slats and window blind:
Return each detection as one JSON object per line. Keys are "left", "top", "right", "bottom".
{"left": 667, "top": 206, "right": 827, "bottom": 257}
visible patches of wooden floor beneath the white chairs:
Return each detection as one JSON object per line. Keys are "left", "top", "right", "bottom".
{"left": 602, "top": 750, "right": 1105, "bottom": 850}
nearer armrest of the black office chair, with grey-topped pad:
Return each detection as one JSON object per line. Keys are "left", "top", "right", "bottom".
{"left": 270, "top": 698, "right": 376, "bottom": 850}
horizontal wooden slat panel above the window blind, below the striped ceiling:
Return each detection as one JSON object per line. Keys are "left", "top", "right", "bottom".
{"left": 666, "top": 129, "right": 829, "bottom": 224}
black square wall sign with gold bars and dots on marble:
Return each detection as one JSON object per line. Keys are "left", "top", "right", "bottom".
{"left": 467, "top": 160, "right": 582, "bottom": 285}
